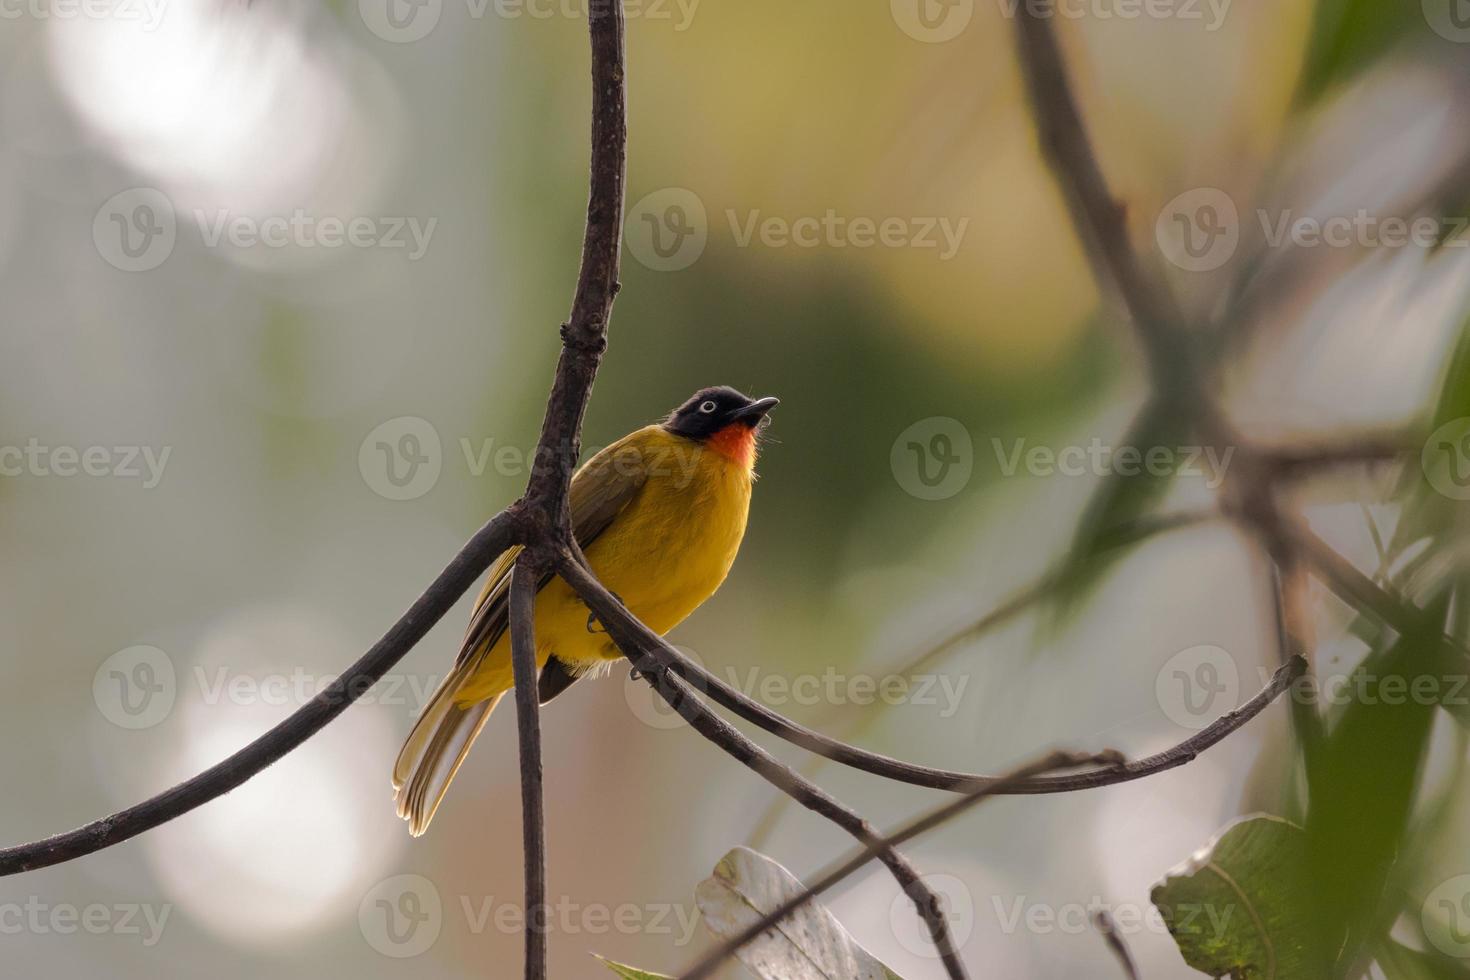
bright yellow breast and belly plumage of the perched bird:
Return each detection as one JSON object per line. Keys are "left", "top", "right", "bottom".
{"left": 456, "top": 437, "right": 753, "bottom": 704}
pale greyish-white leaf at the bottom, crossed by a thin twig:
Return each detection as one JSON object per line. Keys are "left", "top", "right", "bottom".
{"left": 694, "top": 848, "right": 903, "bottom": 980}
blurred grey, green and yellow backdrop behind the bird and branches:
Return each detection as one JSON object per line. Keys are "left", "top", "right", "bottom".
{"left": 0, "top": 0, "right": 1470, "bottom": 980}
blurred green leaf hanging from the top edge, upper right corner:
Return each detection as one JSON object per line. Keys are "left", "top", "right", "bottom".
{"left": 1297, "top": 0, "right": 1422, "bottom": 104}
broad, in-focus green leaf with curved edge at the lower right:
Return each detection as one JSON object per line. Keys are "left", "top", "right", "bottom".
{"left": 1150, "top": 815, "right": 1326, "bottom": 980}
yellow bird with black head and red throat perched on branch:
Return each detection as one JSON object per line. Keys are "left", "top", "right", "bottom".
{"left": 392, "top": 386, "right": 778, "bottom": 836}
